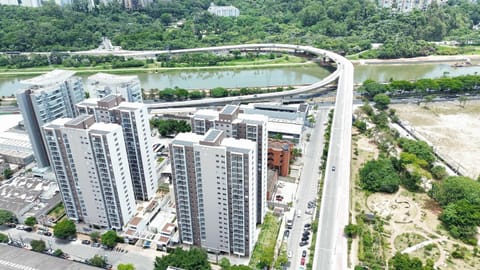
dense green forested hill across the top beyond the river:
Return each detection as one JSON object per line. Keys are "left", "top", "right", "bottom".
{"left": 0, "top": 0, "right": 480, "bottom": 53}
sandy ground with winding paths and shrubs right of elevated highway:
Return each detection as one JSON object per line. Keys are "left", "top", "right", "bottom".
{"left": 350, "top": 118, "right": 480, "bottom": 270}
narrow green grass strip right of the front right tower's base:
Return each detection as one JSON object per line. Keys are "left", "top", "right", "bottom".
{"left": 249, "top": 213, "right": 280, "bottom": 269}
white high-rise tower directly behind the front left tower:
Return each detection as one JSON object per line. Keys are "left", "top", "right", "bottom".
{"left": 76, "top": 95, "right": 158, "bottom": 201}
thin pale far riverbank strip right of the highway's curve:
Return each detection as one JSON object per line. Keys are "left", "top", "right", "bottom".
{"left": 350, "top": 54, "right": 480, "bottom": 65}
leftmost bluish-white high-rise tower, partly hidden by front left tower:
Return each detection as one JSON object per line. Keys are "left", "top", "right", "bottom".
{"left": 16, "top": 70, "right": 84, "bottom": 167}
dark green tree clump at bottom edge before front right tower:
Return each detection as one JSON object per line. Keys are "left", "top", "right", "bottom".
{"left": 155, "top": 247, "right": 211, "bottom": 270}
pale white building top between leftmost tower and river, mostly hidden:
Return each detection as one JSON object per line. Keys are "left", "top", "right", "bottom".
{"left": 85, "top": 73, "right": 142, "bottom": 102}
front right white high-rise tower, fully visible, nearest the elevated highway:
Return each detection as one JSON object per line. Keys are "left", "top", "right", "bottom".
{"left": 169, "top": 129, "right": 257, "bottom": 256}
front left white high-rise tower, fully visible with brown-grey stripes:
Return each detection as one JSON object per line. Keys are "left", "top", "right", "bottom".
{"left": 43, "top": 115, "right": 135, "bottom": 230}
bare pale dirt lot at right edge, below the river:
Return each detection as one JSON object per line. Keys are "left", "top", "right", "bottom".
{"left": 391, "top": 101, "right": 480, "bottom": 179}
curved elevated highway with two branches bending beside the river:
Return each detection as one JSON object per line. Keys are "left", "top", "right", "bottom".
{"left": 77, "top": 44, "right": 353, "bottom": 270}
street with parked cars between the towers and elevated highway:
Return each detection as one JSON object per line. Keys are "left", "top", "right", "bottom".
{"left": 287, "top": 108, "right": 329, "bottom": 269}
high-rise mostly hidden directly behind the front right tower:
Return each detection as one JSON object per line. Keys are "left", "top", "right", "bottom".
{"left": 190, "top": 105, "right": 268, "bottom": 224}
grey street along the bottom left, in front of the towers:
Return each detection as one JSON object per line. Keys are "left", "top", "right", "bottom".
{"left": 0, "top": 227, "right": 161, "bottom": 269}
